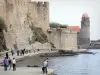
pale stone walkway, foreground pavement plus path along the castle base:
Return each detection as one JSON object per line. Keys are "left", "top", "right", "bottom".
{"left": 0, "top": 50, "right": 55, "bottom": 75}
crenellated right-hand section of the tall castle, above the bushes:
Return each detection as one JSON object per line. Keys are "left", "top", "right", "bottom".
{"left": 28, "top": 1, "right": 49, "bottom": 31}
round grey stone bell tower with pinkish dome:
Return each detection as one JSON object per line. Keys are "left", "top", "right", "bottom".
{"left": 80, "top": 13, "right": 90, "bottom": 48}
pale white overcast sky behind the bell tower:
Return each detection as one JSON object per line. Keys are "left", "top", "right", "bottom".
{"left": 32, "top": 0, "right": 100, "bottom": 40}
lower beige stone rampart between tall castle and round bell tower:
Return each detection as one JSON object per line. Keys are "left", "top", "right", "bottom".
{"left": 49, "top": 28, "right": 77, "bottom": 50}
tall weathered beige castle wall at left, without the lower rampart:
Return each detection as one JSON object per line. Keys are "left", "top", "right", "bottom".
{"left": 0, "top": 0, "right": 49, "bottom": 49}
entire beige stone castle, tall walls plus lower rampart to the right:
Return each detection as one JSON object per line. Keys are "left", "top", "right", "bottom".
{"left": 0, "top": 0, "right": 77, "bottom": 50}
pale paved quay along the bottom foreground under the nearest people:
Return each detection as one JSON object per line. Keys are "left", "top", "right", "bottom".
{"left": 0, "top": 67, "right": 54, "bottom": 75}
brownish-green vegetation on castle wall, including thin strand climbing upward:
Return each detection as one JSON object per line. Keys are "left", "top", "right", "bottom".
{"left": 26, "top": 13, "right": 48, "bottom": 45}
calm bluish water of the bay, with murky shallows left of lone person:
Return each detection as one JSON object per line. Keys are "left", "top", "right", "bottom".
{"left": 18, "top": 50, "right": 100, "bottom": 75}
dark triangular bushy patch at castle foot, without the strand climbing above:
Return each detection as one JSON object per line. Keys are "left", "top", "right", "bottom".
{"left": 29, "top": 23, "right": 48, "bottom": 44}
